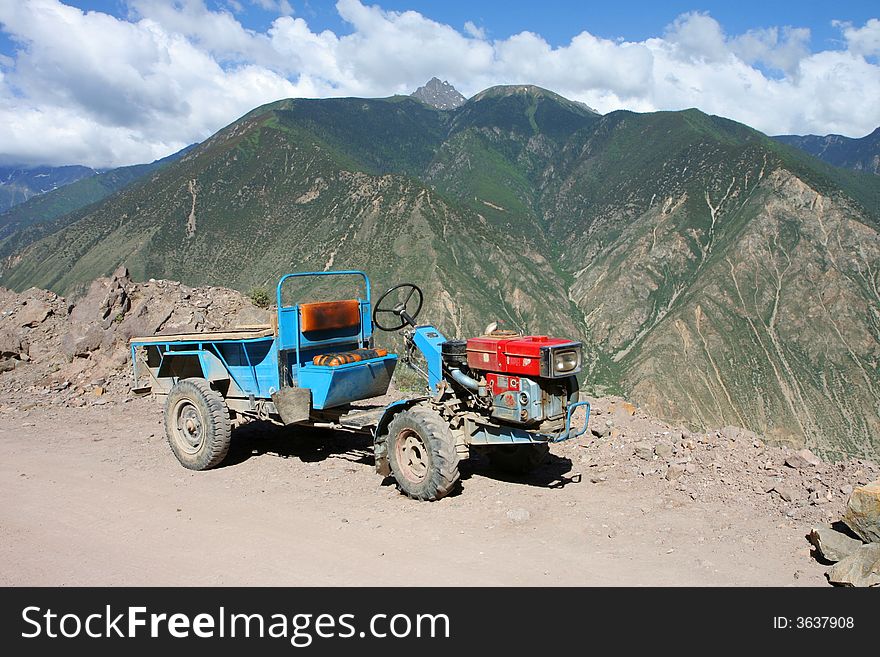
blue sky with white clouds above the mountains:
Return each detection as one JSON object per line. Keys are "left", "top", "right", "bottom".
{"left": 0, "top": 0, "right": 880, "bottom": 167}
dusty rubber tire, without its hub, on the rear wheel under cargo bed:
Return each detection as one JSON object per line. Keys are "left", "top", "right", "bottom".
{"left": 165, "top": 379, "right": 232, "bottom": 470}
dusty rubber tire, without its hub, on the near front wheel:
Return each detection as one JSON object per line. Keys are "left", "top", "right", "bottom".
{"left": 386, "top": 406, "right": 460, "bottom": 502}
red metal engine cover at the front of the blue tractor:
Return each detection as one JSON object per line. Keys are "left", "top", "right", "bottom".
{"left": 467, "top": 335, "right": 582, "bottom": 378}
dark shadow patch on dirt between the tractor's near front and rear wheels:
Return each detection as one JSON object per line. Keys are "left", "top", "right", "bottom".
{"left": 219, "top": 422, "right": 373, "bottom": 468}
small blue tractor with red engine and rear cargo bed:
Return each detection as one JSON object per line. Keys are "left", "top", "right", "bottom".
{"left": 131, "top": 271, "right": 590, "bottom": 500}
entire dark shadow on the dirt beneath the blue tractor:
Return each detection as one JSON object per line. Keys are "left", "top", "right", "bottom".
{"left": 219, "top": 422, "right": 581, "bottom": 495}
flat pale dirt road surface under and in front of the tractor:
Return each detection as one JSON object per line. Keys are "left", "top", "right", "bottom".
{"left": 0, "top": 398, "right": 827, "bottom": 586}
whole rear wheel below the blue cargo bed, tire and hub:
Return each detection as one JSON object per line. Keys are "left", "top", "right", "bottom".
{"left": 165, "top": 379, "right": 231, "bottom": 470}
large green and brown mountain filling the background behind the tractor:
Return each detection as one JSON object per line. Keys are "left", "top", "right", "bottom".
{"left": 0, "top": 85, "right": 880, "bottom": 458}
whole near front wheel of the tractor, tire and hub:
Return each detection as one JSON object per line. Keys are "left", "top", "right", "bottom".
{"left": 387, "top": 406, "right": 459, "bottom": 502}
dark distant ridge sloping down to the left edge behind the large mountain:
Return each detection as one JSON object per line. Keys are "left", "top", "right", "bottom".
{"left": 0, "top": 144, "right": 196, "bottom": 237}
